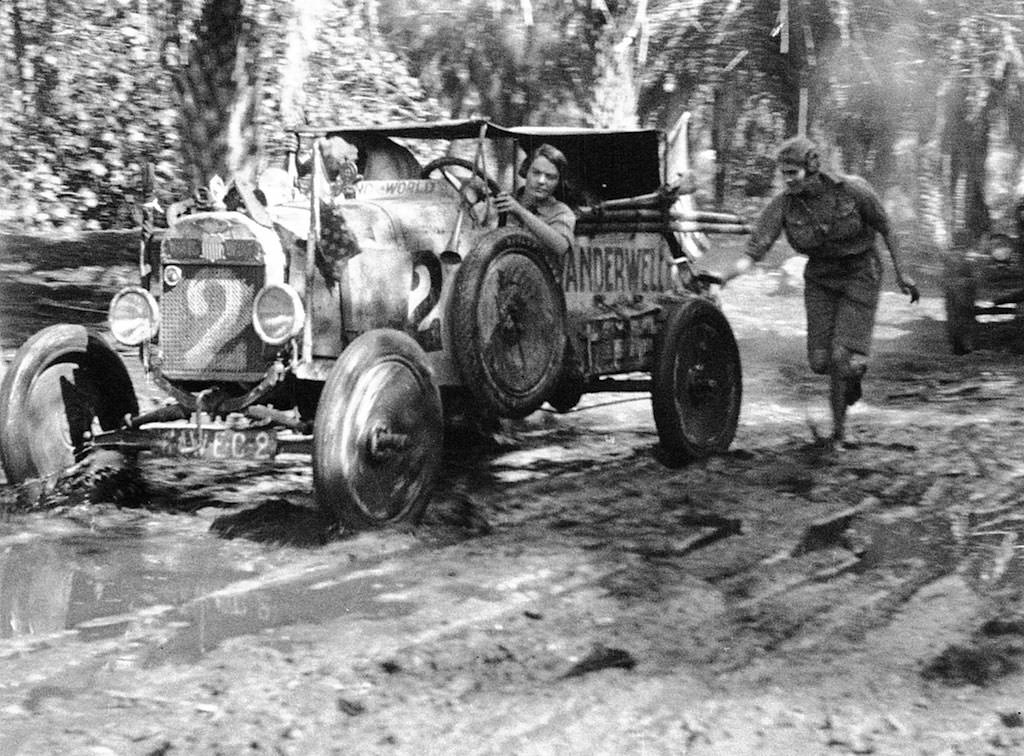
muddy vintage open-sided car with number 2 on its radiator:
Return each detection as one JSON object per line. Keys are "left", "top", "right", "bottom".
{"left": 0, "top": 120, "right": 745, "bottom": 529}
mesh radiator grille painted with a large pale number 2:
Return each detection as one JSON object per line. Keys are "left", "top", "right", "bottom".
{"left": 159, "top": 265, "right": 266, "bottom": 380}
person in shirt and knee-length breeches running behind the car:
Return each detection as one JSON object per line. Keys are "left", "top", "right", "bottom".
{"left": 723, "top": 136, "right": 921, "bottom": 445}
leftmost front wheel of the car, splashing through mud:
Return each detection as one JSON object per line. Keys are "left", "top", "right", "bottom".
{"left": 0, "top": 325, "right": 138, "bottom": 487}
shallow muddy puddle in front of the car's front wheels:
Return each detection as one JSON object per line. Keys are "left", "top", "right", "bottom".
{"left": 0, "top": 497, "right": 436, "bottom": 666}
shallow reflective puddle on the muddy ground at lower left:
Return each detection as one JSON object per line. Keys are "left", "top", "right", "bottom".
{"left": 0, "top": 518, "right": 415, "bottom": 669}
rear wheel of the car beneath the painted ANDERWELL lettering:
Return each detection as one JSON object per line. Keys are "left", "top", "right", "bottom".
{"left": 651, "top": 298, "right": 742, "bottom": 463}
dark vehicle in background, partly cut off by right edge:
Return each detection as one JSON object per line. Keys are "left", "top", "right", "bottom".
{"left": 942, "top": 201, "right": 1024, "bottom": 354}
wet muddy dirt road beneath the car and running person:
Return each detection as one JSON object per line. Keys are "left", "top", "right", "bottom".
{"left": 0, "top": 232, "right": 1024, "bottom": 755}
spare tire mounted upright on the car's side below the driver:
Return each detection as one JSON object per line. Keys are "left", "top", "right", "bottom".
{"left": 450, "top": 228, "right": 566, "bottom": 418}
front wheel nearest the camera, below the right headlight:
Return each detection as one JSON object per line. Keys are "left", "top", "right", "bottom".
{"left": 312, "top": 329, "right": 443, "bottom": 530}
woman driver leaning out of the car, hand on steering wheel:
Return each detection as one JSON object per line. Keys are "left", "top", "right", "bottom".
{"left": 495, "top": 144, "right": 575, "bottom": 270}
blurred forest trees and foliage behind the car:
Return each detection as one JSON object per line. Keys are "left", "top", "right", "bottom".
{"left": 0, "top": 0, "right": 1024, "bottom": 245}
